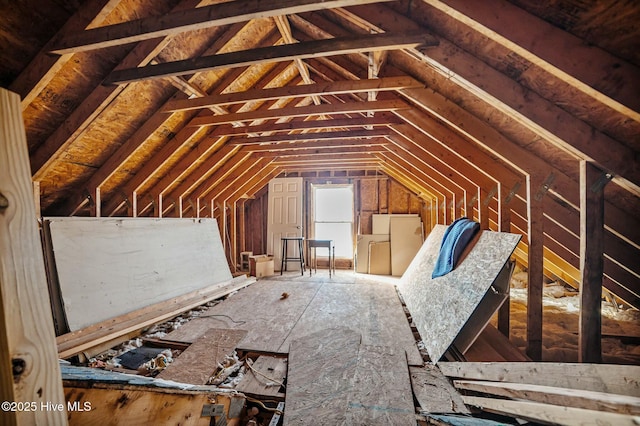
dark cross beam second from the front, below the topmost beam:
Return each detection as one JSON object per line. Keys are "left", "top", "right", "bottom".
{"left": 104, "top": 30, "right": 438, "bottom": 85}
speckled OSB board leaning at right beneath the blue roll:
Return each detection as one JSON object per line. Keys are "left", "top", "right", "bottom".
{"left": 398, "top": 225, "right": 520, "bottom": 362}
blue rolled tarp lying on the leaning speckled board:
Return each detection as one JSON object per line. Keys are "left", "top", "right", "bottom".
{"left": 431, "top": 217, "right": 480, "bottom": 278}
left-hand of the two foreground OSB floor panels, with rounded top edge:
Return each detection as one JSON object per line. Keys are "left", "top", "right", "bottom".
{"left": 283, "top": 327, "right": 361, "bottom": 426}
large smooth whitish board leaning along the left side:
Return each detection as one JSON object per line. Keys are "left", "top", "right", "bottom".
{"left": 46, "top": 217, "right": 232, "bottom": 331}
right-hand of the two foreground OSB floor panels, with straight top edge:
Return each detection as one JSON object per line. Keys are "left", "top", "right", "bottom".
{"left": 346, "top": 345, "right": 416, "bottom": 426}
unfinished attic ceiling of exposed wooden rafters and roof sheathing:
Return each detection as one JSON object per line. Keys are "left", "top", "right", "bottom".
{"left": 0, "top": 0, "right": 640, "bottom": 307}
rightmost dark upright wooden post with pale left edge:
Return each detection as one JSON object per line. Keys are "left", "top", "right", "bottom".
{"left": 578, "top": 161, "right": 611, "bottom": 363}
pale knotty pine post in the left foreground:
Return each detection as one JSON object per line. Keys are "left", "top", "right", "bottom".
{"left": 0, "top": 88, "right": 67, "bottom": 425}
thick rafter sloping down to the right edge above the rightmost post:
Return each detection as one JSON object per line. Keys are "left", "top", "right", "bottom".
{"left": 358, "top": 5, "right": 640, "bottom": 194}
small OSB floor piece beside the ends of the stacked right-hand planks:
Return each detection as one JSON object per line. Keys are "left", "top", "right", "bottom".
{"left": 409, "top": 364, "right": 469, "bottom": 414}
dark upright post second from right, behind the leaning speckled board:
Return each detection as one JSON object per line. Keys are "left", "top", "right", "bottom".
{"left": 527, "top": 175, "right": 546, "bottom": 361}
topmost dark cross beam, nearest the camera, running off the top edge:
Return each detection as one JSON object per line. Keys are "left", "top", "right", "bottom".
{"left": 51, "top": 0, "right": 396, "bottom": 54}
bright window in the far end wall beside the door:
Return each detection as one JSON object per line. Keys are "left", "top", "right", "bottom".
{"left": 312, "top": 184, "right": 353, "bottom": 258}
